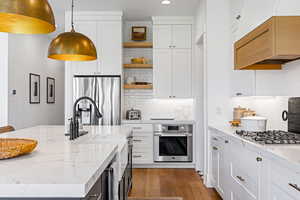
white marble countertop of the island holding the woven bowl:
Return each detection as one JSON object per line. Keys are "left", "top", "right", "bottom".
{"left": 0, "top": 126, "right": 131, "bottom": 198}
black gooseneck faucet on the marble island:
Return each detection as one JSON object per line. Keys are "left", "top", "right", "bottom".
{"left": 70, "top": 97, "right": 102, "bottom": 140}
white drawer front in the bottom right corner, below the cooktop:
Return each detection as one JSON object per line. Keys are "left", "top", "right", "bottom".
{"left": 271, "top": 163, "right": 300, "bottom": 200}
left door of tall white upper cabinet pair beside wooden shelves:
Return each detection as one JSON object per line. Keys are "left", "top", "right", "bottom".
{"left": 153, "top": 49, "right": 172, "bottom": 98}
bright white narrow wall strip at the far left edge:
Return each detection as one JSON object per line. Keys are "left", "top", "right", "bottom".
{"left": 0, "top": 33, "right": 8, "bottom": 127}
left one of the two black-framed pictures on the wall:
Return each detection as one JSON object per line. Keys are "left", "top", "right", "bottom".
{"left": 29, "top": 73, "right": 41, "bottom": 104}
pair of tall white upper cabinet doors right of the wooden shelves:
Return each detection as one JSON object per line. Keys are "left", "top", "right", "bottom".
{"left": 153, "top": 49, "right": 192, "bottom": 98}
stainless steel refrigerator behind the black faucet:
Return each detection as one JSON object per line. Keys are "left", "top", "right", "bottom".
{"left": 73, "top": 76, "right": 121, "bottom": 125}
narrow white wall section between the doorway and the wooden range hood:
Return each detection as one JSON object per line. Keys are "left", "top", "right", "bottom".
{"left": 206, "top": 0, "right": 232, "bottom": 124}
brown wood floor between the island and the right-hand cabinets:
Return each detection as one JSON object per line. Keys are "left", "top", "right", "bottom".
{"left": 130, "top": 169, "right": 221, "bottom": 200}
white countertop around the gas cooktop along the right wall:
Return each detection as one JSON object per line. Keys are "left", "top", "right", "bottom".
{"left": 209, "top": 125, "right": 300, "bottom": 170}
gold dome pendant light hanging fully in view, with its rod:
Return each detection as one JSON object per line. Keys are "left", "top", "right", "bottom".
{"left": 48, "top": 0, "right": 97, "bottom": 61}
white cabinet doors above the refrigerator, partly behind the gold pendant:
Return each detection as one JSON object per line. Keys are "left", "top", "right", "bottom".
{"left": 71, "top": 14, "right": 122, "bottom": 75}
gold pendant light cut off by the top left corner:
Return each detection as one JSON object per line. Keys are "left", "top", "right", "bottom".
{"left": 0, "top": 0, "right": 56, "bottom": 34}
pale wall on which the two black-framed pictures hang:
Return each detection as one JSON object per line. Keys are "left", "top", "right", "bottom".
{"left": 8, "top": 34, "right": 64, "bottom": 129}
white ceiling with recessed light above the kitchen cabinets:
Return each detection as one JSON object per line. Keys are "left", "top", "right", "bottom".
{"left": 49, "top": 0, "right": 198, "bottom": 20}
